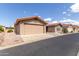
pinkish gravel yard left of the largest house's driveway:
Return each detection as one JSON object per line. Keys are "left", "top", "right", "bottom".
{"left": 0, "top": 33, "right": 23, "bottom": 47}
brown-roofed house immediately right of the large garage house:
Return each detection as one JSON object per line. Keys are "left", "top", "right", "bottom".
{"left": 46, "top": 23, "right": 62, "bottom": 33}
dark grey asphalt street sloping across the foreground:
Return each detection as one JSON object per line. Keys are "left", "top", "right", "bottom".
{"left": 0, "top": 33, "right": 79, "bottom": 56}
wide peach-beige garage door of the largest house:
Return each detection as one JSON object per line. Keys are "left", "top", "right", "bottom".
{"left": 24, "top": 24, "right": 44, "bottom": 34}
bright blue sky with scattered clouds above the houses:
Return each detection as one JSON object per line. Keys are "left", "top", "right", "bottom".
{"left": 0, "top": 3, "right": 79, "bottom": 26}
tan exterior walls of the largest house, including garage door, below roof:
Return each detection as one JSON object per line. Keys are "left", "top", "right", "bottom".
{"left": 16, "top": 20, "right": 46, "bottom": 35}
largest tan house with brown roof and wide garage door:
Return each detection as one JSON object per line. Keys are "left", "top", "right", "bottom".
{"left": 14, "top": 16, "right": 47, "bottom": 35}
